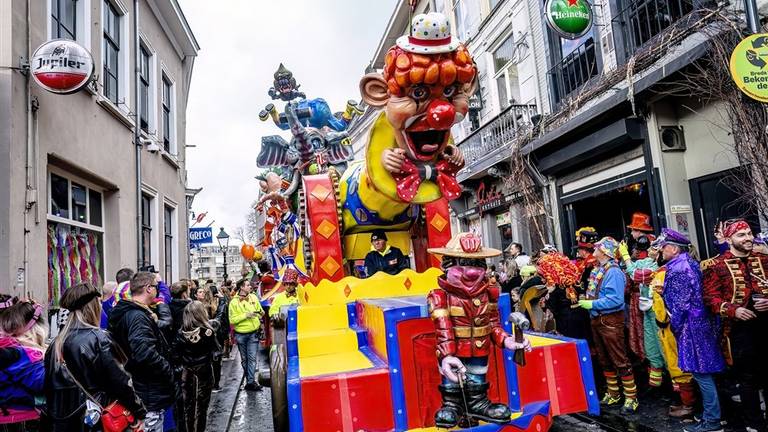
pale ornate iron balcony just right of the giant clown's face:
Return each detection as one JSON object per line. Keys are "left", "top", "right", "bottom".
{"left": 458, "top": 105, "right": 538, "bottom": 180}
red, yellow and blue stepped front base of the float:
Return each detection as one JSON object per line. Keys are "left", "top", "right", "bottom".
{"left": 286, "top": 269, "right": 599, "bottom": 432}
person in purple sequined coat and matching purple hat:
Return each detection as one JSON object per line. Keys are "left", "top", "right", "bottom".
{"left": 654, "top": 228, "right": 725, "bottom": 432}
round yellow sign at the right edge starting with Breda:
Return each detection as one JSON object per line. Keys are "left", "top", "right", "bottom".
{"left": 730, "top": 33, "right": 768, "bottom": 102}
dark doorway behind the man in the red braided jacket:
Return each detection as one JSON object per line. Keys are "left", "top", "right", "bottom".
{"left": 689, "top": 168, "right": 760, "bottom": 258}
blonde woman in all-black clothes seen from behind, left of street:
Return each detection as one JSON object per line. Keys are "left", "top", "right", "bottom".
{"left": 173, "top": 300, "right": 219, "bottom": 432}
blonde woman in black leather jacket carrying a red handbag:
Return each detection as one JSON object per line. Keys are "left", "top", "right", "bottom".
{"left": 45, "top": 283, "right": 147, "bottom": 432}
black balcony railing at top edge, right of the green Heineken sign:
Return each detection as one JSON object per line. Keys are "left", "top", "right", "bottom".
{"left": 613, "top": 0, "right": 715, "bottom": 58}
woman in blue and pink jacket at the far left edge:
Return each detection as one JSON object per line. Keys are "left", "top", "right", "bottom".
{"left": 0, "top": 296, "right": 48, "bottom": 432}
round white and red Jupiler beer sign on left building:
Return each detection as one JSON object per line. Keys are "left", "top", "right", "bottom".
{"left": 29, "top": 39, "right": 93, "bottom": 94}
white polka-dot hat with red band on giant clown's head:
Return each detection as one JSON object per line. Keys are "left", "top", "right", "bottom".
{"left": 397, "top": 12, "right": 459, "bottom": 54}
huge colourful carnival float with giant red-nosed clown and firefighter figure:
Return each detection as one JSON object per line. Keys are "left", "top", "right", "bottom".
{"left": 252, "top": 13, "right": 599, "bottom": 432}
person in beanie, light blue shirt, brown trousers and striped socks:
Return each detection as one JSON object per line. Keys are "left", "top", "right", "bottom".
{"left": 578, "top": 237, "right": 639, "bottom": 414}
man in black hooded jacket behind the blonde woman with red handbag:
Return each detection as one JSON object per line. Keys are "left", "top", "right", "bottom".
{"left": 109, "top": 272, "right": 177, "bottom": 432}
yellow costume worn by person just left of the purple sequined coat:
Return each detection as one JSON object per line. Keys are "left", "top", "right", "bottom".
{"left": 651, "top": 267, "right": 696, "bottom": 407}
